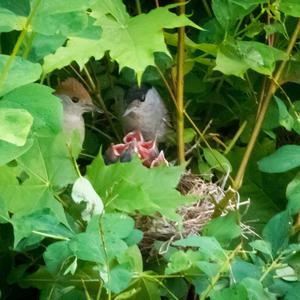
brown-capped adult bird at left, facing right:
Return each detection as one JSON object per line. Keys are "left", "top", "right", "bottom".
{"left": 54, "top": 77, "right": 97, "bottom": 145}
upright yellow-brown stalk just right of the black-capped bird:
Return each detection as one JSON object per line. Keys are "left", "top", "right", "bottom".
{"left": 176, "top": 0, "right": 185, "bottom": 164}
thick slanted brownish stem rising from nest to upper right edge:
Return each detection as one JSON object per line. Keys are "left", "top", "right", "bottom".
{"left": 233, "top": 19, "right": 300, "bottom": 190}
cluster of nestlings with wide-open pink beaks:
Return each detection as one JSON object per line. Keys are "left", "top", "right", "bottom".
{"left": 106, "top": 130, "right": 169, "bottom": 168}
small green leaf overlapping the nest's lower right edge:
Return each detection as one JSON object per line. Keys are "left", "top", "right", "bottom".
{"left": 202, "top": 212, "right": 241, "bottom": 247}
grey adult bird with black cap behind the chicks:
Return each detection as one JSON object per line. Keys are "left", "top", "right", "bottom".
{"left": 122, "top": 85, "right": 169, "bottom": 142}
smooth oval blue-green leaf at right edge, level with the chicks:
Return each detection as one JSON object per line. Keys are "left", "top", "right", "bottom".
{"left": 258, "top": 145, "right": 300, "bottom": 173}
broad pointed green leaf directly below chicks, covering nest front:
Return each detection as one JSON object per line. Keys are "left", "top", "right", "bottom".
{"left": 87, "top": 156, "right": 189, "bottom": 220}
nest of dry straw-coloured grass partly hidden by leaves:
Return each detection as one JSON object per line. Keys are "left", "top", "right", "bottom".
{"left": 136, "top": 172, "right": 243, "bottom": 256}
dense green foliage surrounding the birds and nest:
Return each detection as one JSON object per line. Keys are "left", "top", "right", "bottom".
{"left": 0, "top": 0, "right": 300, "bottom": 300}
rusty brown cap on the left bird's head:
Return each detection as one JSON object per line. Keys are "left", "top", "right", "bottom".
{"left": 55, "top": 77, "right": 93, "bottom": 104}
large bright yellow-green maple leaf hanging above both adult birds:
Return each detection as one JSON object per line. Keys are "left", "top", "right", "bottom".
{"left": 43, "top": 0, "right": 201, "bottom": 79}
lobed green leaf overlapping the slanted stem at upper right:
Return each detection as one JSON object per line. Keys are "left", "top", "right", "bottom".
{"left": 215, "top": 40, "right": 288, "bottom": 78}
